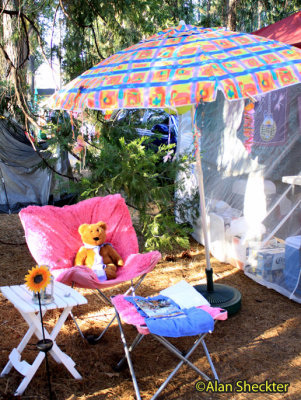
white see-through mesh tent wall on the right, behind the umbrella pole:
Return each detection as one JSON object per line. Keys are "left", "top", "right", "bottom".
{"left": 177, "top": 84, "right": 301, "bottom": 303}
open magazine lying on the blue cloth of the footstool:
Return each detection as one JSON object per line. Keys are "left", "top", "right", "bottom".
{"left": 133, "top": 298, "right": 185, "bottom": 318}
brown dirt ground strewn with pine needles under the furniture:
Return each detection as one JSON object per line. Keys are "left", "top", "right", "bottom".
{"left": 0, "top": 215, "right": 301, "bottom": 400}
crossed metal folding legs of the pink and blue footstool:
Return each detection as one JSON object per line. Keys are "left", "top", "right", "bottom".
{"left": 114, "top": 306, "right": 219, "bottom": 400}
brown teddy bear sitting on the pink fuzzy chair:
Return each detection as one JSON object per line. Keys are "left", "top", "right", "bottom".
{"left": 74, "top": 221, "right": 124, "bottom": 281}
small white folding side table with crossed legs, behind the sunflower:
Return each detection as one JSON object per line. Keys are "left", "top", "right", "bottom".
{"left": 0, "top": 282, "right": 87, "bottom": 396}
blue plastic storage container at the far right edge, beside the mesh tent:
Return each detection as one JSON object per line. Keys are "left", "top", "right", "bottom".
{"left": 283, "top": 236, "right": 301, "bottom": 295}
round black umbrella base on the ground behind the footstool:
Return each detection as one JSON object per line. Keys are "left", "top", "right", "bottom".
{"left": 194, "top": 283, "right": 241, "bottom": 315}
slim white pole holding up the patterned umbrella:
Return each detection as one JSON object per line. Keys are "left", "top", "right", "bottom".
{"left": 191, "top": 105, "right": 213, "bottom": 291}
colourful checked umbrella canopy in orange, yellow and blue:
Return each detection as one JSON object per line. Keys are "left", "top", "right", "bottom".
{"left": 50, "top": 24, "right": 301, "bottom": 111}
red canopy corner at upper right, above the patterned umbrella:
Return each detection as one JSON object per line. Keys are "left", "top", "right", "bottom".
{"left": 252, "top": 11, "right": 301, "bottom": 48}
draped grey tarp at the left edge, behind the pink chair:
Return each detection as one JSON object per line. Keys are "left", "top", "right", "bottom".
{"left": 0, "top": 117, "right": 52, "bottom": 213}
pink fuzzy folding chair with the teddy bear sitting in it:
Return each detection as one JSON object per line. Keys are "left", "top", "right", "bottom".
{"left": 19, "top": 194, "right": 161, "bottom": 342}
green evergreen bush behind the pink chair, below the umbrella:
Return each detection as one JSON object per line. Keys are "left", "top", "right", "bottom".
{"left": 47, "top": 114, "right": 196, "bottom": 250}
